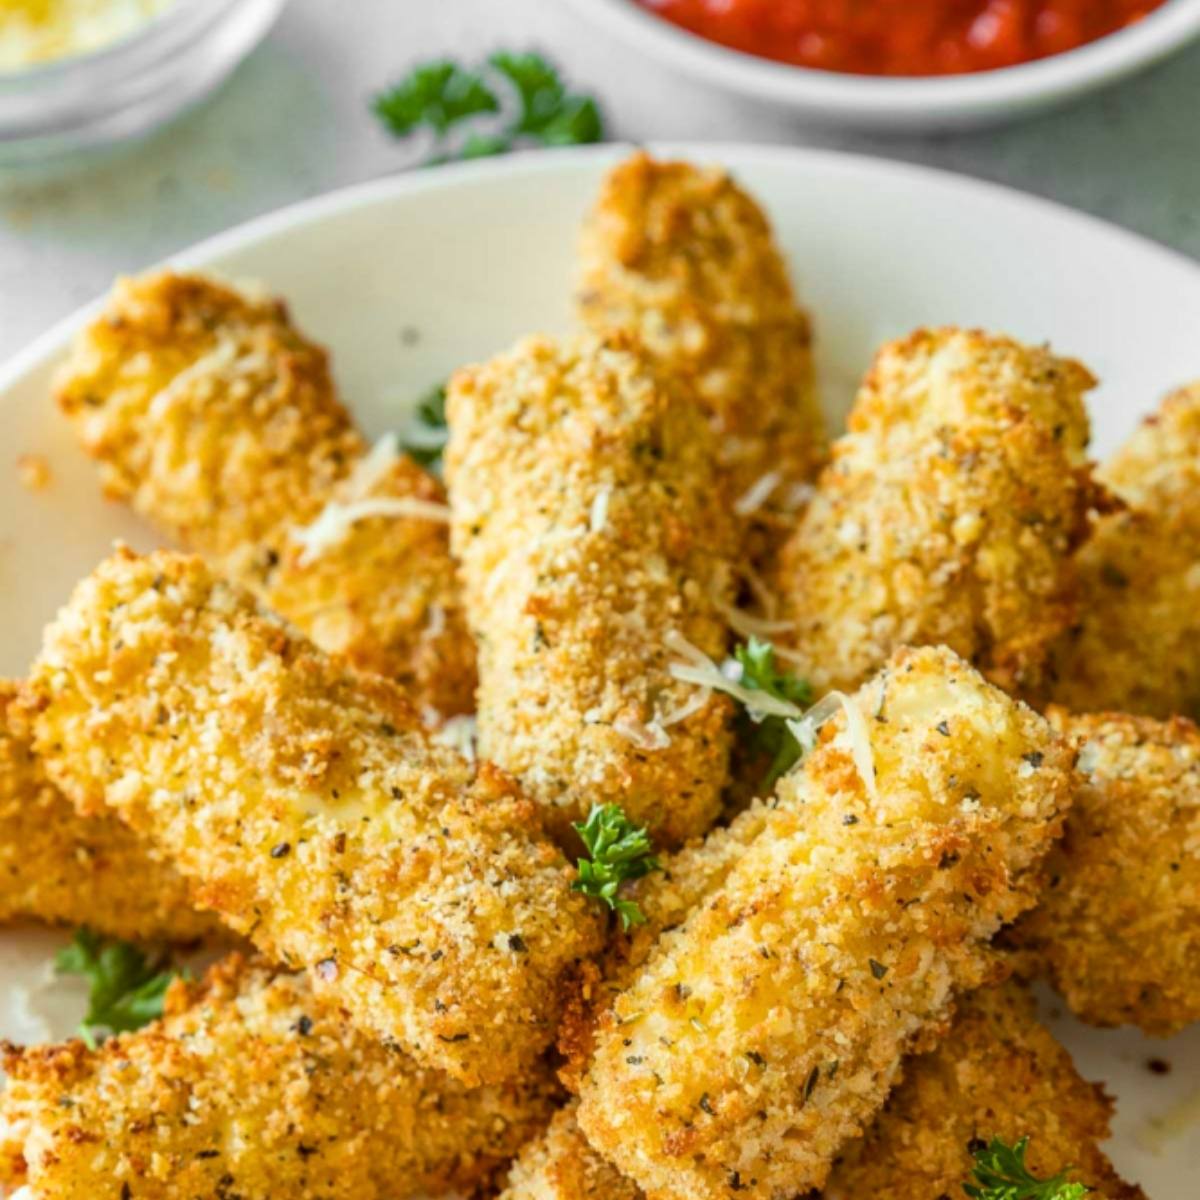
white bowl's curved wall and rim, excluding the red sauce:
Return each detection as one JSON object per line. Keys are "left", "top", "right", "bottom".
{"left": 571, "top": 0, "right": 1200, "bottom": 131}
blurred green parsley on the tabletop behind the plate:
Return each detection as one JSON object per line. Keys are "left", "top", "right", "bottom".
{"left": 372, "top": 50, "right": 604, "bottom": 162}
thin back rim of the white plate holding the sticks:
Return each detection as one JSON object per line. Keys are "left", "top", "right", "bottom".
{"left": 0, "top": 140, "right": 1200, "bottom": 406}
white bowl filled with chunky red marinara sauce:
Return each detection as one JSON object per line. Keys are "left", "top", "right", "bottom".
{"left": 561, "top": 0, "right": 1200, "bottom": 130}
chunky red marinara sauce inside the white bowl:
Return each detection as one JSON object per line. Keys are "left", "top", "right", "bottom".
{"left": 637, "top": 0, "right": 1164, "bottom": 76}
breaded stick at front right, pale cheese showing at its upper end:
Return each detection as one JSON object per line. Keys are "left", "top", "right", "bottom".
{"left": 578, "top": 648, "right": 1074, "bottom": 1200}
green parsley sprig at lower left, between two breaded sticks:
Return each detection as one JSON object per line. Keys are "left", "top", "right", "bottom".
{"left": 54, "top": 929, "right": 180, "bottom": 1050}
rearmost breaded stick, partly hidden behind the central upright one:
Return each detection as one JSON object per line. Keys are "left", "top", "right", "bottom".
{"left": 577, "top": 154, "right": 826, "bottom": 549}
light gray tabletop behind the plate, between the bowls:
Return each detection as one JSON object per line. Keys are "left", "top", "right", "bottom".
{"left": 0, "top": 0, "right": 1200, "bottom": 360}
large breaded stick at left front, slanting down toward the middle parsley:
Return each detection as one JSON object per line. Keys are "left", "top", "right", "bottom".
{"left": 24, "top": 551, "right": 599, "bottom": 1082}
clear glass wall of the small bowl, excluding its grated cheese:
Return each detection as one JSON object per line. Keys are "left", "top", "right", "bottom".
{"left": 0, "top": 0, "right": 287, "bottom": 179}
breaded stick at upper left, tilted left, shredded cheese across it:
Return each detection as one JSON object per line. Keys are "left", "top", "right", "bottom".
{"left": 56, "top": 271, "right": 475, "bottom": 715}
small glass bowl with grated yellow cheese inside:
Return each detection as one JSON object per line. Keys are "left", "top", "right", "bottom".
{"left": 0, "top": 0, "right": 286, "bottom": 176}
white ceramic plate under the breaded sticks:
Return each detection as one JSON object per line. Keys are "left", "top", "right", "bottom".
{"left": 0, "top": 145, "right": 1200, "bottom": 1200}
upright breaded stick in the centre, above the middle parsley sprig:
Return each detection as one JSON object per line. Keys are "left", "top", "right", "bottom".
{"left": 445, "top": 335, "right": 733, "bottom": 844}
